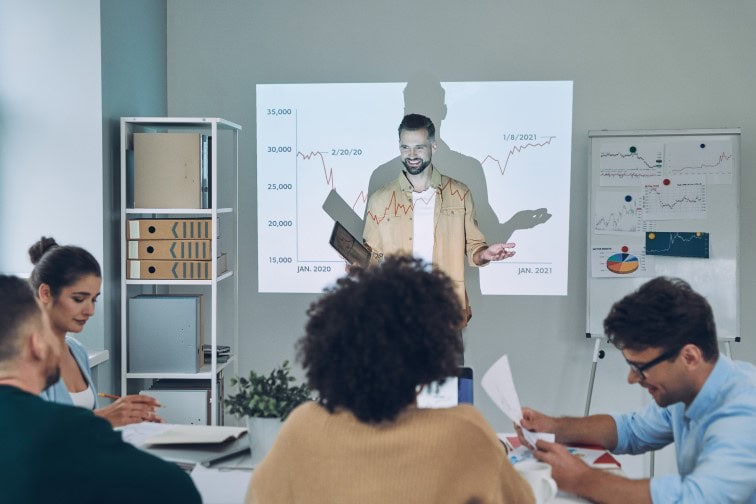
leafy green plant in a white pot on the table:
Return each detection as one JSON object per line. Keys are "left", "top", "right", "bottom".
{"left": 226, "top": 360, "right": 311, "bottom": 463}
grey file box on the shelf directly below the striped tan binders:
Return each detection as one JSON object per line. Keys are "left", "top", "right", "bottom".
{"left": 128, "top": 294, "right": 204, "bottom": 373}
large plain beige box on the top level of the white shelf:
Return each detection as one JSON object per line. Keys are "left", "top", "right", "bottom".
{"left": 134, "top": 133, "right": 209, "bottom": 208}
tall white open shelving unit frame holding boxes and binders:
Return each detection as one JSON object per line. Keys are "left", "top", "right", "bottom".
{"left": 120, "top": 117, "right": 241, "bottom": 425}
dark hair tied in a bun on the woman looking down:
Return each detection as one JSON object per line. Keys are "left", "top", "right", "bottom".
{"left": 29, "top": 236, "right": 102, "bottom": 298}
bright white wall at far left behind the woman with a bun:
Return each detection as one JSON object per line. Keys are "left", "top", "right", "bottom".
{"left": 0, "top": 0, "right": 104, "bottom": 349}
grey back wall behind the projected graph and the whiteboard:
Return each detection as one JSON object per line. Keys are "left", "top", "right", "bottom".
{"left": 168, "top": 0, "right": 756, "bottom": 475}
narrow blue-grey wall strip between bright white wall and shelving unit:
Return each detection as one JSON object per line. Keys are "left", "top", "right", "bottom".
{"left": 98, "top": 0, "right": 167, "bottom": 391}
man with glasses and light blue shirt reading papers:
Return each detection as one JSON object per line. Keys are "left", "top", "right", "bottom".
{"left": 518, "top": 277, "right": 756, "bottom": 504}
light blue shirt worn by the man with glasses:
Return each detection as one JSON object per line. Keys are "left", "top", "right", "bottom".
{"left": 612, "top": 355, "right": 756, "bottom": 504}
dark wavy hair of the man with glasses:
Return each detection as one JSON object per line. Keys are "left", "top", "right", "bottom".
{"left": 604, "top": 277, "right": 719, "bottom": 361}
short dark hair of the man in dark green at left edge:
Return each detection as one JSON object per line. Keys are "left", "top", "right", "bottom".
{"left": 0, "top": 275, "right": 41, "bottom": 366}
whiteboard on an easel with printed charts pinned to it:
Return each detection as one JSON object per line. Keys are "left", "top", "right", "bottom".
{"left": 586, "top": 128, "right": 740, "bottom": 340}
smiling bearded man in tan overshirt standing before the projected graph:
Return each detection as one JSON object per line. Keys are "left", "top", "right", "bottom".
{"left": 363, "top": 114, "right": 515, "bottom": 336}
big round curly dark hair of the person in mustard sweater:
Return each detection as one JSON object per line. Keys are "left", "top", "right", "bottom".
{"left": 297, "top": 256, "right": 463, "bottom": 423}
